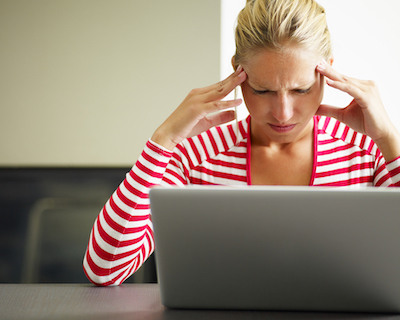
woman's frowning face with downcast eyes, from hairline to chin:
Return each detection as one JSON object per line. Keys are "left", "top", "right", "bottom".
{"left": 242, "top": 47, "right": 325, "bottom": 143}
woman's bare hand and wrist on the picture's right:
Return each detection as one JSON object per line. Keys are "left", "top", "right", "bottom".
{"left": 317, "top": 61, "right": 400, "bottom": 162}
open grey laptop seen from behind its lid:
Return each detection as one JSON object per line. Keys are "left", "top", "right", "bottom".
{"left": 150, "top": 186, "right": 400, "bottom": 313}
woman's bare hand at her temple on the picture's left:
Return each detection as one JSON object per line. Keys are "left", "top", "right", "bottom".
{"left": 151, "top": 66, "right": 247, "bottom": 151}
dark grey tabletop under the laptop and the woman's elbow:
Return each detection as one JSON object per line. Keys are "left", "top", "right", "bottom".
{"left": 0, "top": 284, "right": 400, "bottom": 320}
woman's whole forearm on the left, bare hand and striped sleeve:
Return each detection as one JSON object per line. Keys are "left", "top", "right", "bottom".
{"left": 83, "top": 68, "right": 246, "bottom": 286}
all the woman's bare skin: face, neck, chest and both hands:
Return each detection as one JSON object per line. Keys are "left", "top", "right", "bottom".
{"left": 152, "top": 45, "right": 400, "bottom": 185}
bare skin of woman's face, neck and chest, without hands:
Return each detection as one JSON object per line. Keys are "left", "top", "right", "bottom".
{"left": 238, "top": 46, "right": 324, "bottom": 185}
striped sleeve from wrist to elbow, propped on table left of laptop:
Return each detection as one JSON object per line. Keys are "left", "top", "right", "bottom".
{"left": 83, "top": 140, "right": 174, "bottom": 286}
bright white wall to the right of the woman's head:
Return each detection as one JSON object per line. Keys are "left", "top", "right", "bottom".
{"left": 318, "top": 0, "right": 400, "bottom": 130}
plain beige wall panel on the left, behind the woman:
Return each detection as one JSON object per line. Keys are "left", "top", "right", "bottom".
{"left": 0, "top": 0, "right": 220, "bottom": 166}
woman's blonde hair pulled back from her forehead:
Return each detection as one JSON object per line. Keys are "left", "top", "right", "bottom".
{"left": 234, "top": 0, "right": 332, "bottom": 69}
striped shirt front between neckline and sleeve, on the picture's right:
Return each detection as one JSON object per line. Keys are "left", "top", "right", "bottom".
{"left": 312, "top": 117, "right": 392, "bottom": 187}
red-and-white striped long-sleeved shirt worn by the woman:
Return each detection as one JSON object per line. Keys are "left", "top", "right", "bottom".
{"left": 83, "top": 116, "right": 400, "bottom": 285}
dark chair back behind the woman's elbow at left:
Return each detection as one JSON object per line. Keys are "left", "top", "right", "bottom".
{"left": 21, "top": 198, "right": 157, "bottom": 283}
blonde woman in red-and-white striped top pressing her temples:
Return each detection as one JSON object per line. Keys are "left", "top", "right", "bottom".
{"left": 84, "top": 0, "right": 400, "bottom": 285}
